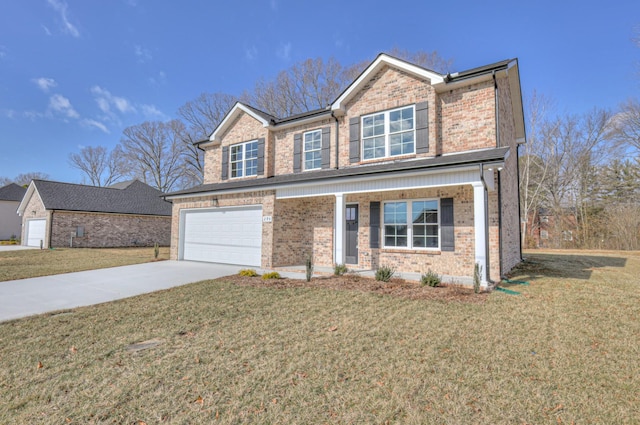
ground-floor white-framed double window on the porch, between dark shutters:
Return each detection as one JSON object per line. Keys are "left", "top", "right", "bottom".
{"left": 383, "top": 200, "right": 440, "bottom": 249}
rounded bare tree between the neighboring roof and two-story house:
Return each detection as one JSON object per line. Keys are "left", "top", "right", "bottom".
{"left": 121, "top": 120, "right": 185, "bottom": 192}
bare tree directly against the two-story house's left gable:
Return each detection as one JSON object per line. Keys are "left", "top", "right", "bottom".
{"left": 178, "top": 93, "right": 238, "bottom": 187}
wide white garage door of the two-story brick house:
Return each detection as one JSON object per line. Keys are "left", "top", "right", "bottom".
{"left": 181, "top": 206, "right": 262, "bottom": 267}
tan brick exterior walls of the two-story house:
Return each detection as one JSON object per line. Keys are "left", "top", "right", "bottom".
{"left": 182, "top": 58, "right": 520, "bottom": 281}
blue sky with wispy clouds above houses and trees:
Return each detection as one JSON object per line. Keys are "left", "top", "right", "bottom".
{"left": 0, "top": 0, "right": 640, "bottom": 183}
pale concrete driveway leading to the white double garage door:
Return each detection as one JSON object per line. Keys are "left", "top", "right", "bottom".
{"left": 0, "top": 261, "right": 264, "bottom": 321}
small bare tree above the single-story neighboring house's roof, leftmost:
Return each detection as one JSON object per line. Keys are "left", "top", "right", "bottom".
{"left": 69, "top": 145, "right": 129, "bottom": 186}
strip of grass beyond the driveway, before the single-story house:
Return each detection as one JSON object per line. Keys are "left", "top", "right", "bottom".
{"left": 0, "top": 247, "right": 169, "bottom": 282}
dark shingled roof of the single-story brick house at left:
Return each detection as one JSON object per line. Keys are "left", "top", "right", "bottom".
{"left": 33, "top": 180, "right": 171, "bottom": 216}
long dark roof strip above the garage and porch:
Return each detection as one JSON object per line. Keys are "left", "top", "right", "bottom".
{"left": 166, "top": 147, "right": 509, "bottom": 196}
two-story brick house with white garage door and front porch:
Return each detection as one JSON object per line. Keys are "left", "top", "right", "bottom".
{"left": 167, "top": 54, "right": 525, "bottom": 285}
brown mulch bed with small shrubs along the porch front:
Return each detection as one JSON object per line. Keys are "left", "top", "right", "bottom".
{"left": 220, "top": 274, "right": 488, "bottom": 304}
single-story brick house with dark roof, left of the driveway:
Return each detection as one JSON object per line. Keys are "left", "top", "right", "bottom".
{"left": 18, "top": 180, "right": 171, "bottom": 248}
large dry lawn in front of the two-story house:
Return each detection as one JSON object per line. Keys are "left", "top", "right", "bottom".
{"left": 0, "top": 253, "right": 640, "bottom": 424}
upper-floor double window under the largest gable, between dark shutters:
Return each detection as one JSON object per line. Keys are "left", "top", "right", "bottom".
{"left": 362, "top": 106, "right": 416, "bottom": 160}
